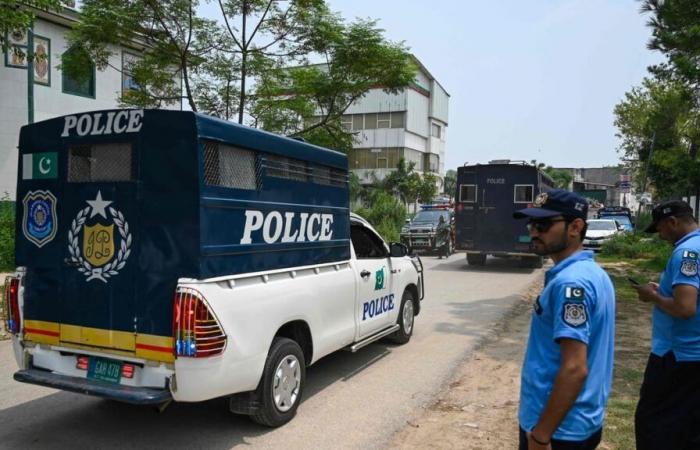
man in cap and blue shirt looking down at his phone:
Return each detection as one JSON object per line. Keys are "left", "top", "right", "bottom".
{"left": 634, "top": 201, "right": 700, "bottom": 450}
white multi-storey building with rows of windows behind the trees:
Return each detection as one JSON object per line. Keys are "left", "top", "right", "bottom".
{"left": 342, "top": 59, "right": 450, "bottom": 184}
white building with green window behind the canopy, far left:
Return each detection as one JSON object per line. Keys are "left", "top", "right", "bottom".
{"left": 0, "top": 8, "right": 179, "bottom": 200}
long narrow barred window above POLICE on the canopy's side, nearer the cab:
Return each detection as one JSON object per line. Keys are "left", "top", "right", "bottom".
{"left": 265, "top": 155, "right": 348, "bottom": 186}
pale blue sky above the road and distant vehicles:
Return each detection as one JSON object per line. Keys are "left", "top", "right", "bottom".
{"left": 328, "top": 0, "right": 662, "bottom": 169}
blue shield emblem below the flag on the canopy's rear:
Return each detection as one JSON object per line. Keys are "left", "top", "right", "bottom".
{"left": 22, "top": 191, "right": 56, "bottom": 248}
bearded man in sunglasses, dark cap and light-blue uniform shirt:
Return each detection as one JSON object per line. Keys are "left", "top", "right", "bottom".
{"left": 513, "top": 189, "right": 615, "bottom": 450}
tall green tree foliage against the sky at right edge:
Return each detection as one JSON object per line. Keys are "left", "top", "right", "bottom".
{"left": 614, "top": 0, "right": 700, "bottom": 198}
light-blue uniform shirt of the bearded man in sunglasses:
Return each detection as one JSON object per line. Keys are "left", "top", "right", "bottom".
{"left": 518, "top": 251, "right": 615, "bottom": 441}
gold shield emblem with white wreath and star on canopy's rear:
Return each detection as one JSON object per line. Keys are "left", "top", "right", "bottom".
{"left": 68, "top": 191, "right": 132, "bottom": 283}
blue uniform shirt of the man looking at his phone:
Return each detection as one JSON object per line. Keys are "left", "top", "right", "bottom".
{"left": 651, "top": 230, "right": 700, "bottom": 361}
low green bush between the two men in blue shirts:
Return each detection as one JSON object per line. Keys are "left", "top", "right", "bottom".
{"left": 601, "top": 232, "right": 673, "bottom": 269}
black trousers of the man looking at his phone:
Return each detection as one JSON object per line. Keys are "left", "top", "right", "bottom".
{"left": 634, "top": 352, "right": 700, "bottom": 450}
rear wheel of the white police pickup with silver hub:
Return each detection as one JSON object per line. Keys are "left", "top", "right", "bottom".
{"left": 251, "top": 337, "right": 306, "bottom": 427}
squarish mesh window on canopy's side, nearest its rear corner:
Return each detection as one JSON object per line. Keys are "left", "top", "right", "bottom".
{"left": 204, "top": 141, "right": 260, "bottom": 190}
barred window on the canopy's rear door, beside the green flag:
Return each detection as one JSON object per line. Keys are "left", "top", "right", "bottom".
{"left": 68, "top": 142, "right": 134, "bottom": 183}
